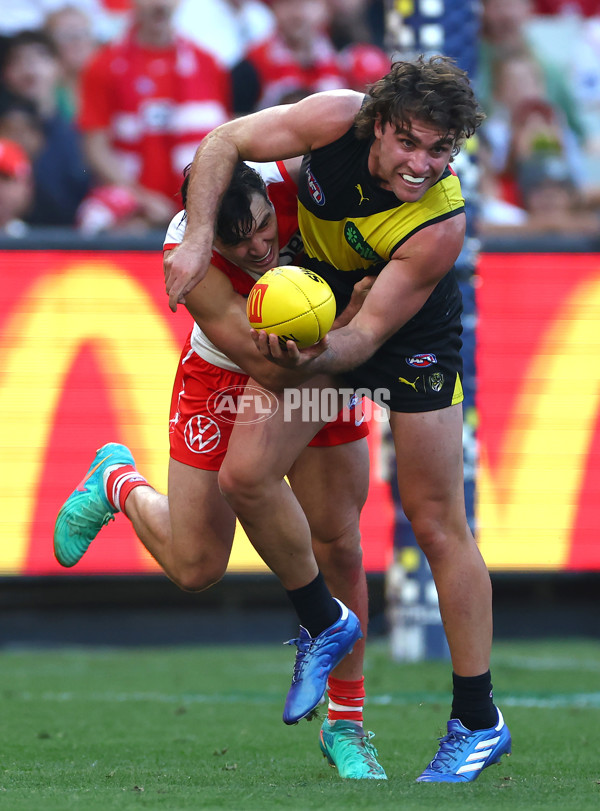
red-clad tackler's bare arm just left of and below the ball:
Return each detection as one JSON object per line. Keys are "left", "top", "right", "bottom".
{"left": 185, "top": 265, "right": 304, "bottom": 389}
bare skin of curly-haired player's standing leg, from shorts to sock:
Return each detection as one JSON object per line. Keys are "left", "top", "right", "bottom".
{"left": 390, "top": 405, "right": 492, "bottom": 676}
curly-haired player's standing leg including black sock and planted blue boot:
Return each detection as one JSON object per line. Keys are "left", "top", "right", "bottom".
{"left": 390, "top": 405, "right": 511, "bottom": 783}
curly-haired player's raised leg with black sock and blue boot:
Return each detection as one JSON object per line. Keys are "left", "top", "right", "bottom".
{"left": 219, "top": 381, "right": 362, "bottom": 724}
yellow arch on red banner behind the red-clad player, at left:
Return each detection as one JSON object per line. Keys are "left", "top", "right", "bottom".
{"left": 0, "top": 259, "right": 262, "bottom": 572}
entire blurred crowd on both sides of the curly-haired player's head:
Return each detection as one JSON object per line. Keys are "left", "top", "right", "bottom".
{"left": 0, "top": 0, "right": 600, "bottom": 236}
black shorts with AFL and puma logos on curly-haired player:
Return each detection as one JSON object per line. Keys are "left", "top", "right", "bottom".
{"left": 304, "top": 263, "right": 463, "bottom": 413}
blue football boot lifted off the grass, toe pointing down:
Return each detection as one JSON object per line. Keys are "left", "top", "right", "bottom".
{"left": 283, "top": 598, "right": 362, "bottom": 724}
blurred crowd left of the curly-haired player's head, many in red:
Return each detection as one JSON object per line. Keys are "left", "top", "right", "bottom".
{"left": 0, "top": 0, "right": 390, "bottom": 235}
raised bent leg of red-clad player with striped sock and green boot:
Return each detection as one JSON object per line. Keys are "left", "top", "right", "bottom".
{"left": 54, "top": 442, "right": 235, "bottom": 591}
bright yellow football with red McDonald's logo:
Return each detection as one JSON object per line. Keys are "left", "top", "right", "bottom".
{"left": 246, "top": 265, "right": 335, "bottom": 349}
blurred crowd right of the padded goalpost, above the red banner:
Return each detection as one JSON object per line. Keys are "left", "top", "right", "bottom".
{"left": 475, "top": 0, "right": 600, "bottom": 236}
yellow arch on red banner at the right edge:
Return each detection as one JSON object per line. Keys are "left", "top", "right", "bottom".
{"left": 478, "top": 279, "right": 600, "bottom": 569}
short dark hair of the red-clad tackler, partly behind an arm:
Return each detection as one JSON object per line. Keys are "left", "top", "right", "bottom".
{"left": 181, "top": 161, "right": 271, "bottom": 245}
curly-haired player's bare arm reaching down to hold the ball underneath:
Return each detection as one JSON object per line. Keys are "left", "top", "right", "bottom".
{"left": 255, "top": 214, "right": 465, "bottom": 385}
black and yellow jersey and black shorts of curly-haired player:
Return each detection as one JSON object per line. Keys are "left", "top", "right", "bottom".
{"left": 298, "top": 120, "right": 464, "bottom": 412}
